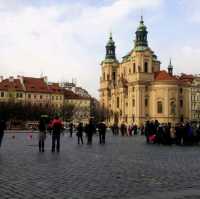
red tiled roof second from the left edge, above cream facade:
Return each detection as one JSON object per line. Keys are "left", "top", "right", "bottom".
{"left": 23, "top": 77, "right": 49, "bottom": 93}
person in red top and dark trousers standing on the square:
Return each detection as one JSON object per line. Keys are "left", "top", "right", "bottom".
{"left": 52, "top": 116, "right": 63, "bottom": 152}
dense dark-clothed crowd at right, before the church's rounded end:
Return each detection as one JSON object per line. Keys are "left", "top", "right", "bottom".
{"left": 144, "top": 120, "right": 200, "bottom": 145}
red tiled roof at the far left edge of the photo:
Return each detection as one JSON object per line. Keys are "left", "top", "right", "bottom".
{"left": 0, "top": 79, "right": 23, "bottom": 91}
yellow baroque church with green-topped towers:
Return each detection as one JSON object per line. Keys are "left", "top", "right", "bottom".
{"left": 99, "top": 17, "right": 191, "bottom": 126}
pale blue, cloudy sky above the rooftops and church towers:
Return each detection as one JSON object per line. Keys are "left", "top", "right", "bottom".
{"left": 0, "top": 0, "right": 200, "bottom": 97}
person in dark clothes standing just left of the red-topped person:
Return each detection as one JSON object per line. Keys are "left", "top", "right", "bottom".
{"left": 38, "top": 117, "right": 46, "bottom": 152}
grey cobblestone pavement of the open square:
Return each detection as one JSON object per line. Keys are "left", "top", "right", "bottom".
{"left": 0, "top": 131, "right": 200, "bottom": 199}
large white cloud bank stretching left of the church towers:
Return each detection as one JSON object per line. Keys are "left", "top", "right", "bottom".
{"left": 0, "top": 0, "right": 161, "bottom": 96}
